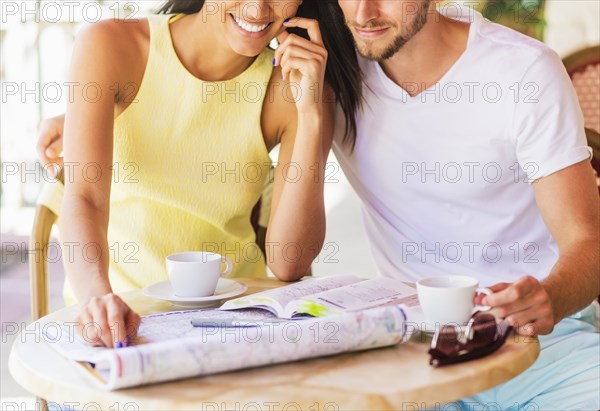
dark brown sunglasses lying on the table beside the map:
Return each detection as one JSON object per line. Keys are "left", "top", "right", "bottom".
{"left": 429, "top": 312, "right": 512, "bottom": 367}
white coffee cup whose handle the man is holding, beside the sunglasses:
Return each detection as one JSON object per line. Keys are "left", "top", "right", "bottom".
{"left": 417, "top": 275, "right": 493, "bottom": 325}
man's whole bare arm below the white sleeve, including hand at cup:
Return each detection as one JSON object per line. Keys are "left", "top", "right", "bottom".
{"left": 483, "top": 161, "right": 600, "bottom": 335}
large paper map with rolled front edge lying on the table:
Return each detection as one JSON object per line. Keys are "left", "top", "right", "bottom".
{"left": 41, "top": 306, "right": 408, "bottom": 390}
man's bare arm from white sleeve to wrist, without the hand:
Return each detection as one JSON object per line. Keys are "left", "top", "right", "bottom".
{"left": 534, "top": 161, "right": 600, "bottom": 322}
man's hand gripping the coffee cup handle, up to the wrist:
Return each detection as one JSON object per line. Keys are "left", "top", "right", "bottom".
{"left": 476, "top": 276, "right": 555, "bottom": 336}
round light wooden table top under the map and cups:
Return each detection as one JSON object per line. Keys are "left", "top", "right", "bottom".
{"left": 9, "top": 279, "right": 539, "bottom": 411}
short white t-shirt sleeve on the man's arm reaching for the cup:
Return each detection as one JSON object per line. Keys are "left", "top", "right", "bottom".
{"left": 512, "top": 50, "right": 592, "bottom": 181}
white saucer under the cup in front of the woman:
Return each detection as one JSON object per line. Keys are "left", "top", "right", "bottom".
{"left": 143, "top": 278, "right": 248, "bottom": 308}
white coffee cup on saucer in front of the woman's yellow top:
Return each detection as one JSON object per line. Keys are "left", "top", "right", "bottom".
{"left": 167, "top": 251, "right": 233, "bottom": 297}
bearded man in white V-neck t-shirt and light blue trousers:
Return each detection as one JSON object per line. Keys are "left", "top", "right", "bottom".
{"left": 334, "top": 0, "right": 600, "bottom": 410}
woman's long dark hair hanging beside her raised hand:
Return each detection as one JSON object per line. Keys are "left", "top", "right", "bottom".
{"left": 158, "top": 0, "right": 362, "bottom": 149}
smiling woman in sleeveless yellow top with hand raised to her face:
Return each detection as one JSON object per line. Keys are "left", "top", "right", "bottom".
{"left": 42, "top": 0, "right": 360, "bottom": 347}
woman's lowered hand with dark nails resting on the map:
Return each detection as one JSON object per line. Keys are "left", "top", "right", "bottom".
{"left": 75, "top": 293, "right": 140, "bottom": 348}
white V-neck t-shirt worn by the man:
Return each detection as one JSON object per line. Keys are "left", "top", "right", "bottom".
{"left": 334, "top": 10, "right": 590, "bottom": 285}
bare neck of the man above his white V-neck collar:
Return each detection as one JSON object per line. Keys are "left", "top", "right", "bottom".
{"left": 381, "top": 12, "right": 470, "bottom": 97}
